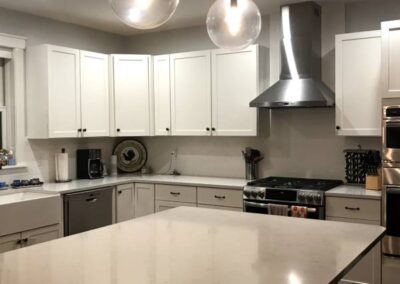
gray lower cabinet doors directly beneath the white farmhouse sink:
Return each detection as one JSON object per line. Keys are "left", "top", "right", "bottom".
{"left": 0, "top": 224, "right": 62, "bottom": 253}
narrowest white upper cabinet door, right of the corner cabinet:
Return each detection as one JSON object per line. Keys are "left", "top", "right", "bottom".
{"left": 153, "top": 55, "right": 171, "bottom": 136}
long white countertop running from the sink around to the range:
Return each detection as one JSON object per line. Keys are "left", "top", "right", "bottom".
{"left": 37, "top": 175, "right": 248, "bottom": 194}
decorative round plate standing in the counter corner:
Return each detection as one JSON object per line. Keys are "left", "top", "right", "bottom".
{"left": 114, "top": 140, "right": 147, "bottom": 173}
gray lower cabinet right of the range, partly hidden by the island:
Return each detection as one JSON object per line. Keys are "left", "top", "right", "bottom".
{"left": 326, "top": 196, "right": 382, "bottom": 284}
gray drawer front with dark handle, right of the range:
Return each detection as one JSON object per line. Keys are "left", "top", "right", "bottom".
{"left": 326, "top": 197, "right": 381, "bottom": 222}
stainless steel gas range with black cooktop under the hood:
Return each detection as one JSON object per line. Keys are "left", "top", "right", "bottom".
{"left": 243, "top": 177, "right": 343, "bottom": 219}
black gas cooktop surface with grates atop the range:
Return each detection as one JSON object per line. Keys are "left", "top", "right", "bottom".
{"left": 247, "top": 177, "right": 343, "bottom": 191}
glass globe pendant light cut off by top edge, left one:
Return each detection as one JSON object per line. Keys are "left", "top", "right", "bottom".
{"left": 110, "top": 0, "right": 179, "bottom": 29}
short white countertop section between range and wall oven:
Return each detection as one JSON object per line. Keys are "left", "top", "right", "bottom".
{"left": 325, "top": 185, "right": 382, "bottom": 200}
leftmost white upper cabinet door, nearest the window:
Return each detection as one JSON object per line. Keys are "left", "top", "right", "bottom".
{"left": 47, "top": 46, "right": 81, "bottom": 138}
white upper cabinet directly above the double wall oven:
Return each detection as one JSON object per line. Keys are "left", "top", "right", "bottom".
{"left": 382, "top": 20, "right": 400, "bottom": 98}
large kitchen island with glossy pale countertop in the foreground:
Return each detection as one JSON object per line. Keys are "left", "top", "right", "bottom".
{"left": 0, "top": 207, "right": 385, "bottom": 284}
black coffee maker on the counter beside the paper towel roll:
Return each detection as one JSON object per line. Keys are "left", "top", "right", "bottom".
{"left": 76, "top": 149, "right": 104, "bottom": 179}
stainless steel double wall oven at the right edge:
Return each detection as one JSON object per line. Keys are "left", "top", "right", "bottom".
{"left": 382, "top": 99, "right": 400, "bottom": 256}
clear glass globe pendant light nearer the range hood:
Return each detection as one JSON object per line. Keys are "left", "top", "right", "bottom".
{"left": 207, "top": 0, "right": 261, "bottom": 50}
